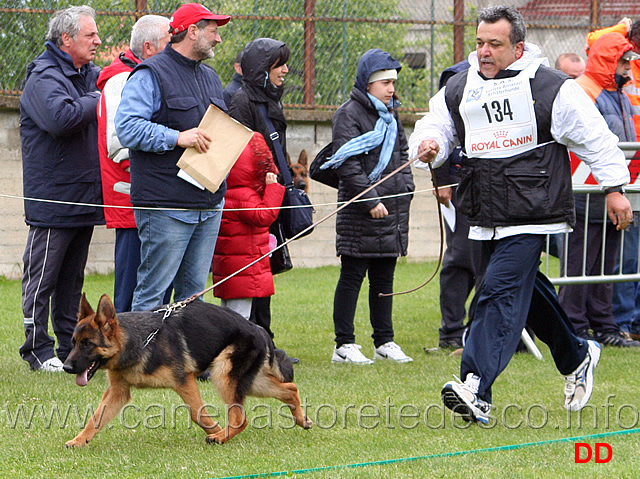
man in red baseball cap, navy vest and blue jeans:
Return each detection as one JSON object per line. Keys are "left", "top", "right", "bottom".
{"left": 115, "top": 3, "right": 231, "bottom": 311}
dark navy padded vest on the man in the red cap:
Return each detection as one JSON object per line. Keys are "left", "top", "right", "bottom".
{"left": 130, "top": 45, "right": 227, "bottom": 209}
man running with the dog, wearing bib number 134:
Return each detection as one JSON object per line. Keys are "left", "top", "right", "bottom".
{"left": 409, "top": 6, "right": 632, "bottom": 424}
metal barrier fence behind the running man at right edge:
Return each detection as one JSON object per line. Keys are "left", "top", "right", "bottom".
{"left": 542, "top": 142, "right": 640, "bottom": 286}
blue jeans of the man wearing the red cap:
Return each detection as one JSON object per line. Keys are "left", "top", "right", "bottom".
{"left": 131, "top": 207, "right": 223, "bottom": 311}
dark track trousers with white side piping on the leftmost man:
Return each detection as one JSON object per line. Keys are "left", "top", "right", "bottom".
{"left": 20, "top": 226, "right": 93, "bottom": 369}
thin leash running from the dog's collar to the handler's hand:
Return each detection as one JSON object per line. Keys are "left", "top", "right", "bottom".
{"left": 142, "top": 151, "right": 444, "bottom": 348}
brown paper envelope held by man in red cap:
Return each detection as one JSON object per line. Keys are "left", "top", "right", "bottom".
{"left": 177, "top": 105, "right": 253, "bottom": 193}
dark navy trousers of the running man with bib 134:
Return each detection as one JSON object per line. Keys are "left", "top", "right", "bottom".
{"left": 460, "top": 234, "right": 587, "bottom": 402}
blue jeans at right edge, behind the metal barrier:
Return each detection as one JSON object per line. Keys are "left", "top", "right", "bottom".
{"left": 613, "top": 221, "right": 640, "bottom": 332}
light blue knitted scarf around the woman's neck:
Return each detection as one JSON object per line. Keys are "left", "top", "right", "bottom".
{"left": 320, "top": 93, "right": 398, "bottom": 182}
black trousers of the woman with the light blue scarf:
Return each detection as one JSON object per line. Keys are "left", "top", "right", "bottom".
{"left": 333, "top": 255, "right": 397, "bottom": 347}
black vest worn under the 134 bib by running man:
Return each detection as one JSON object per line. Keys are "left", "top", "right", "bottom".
{"left": 445, "top": 66, "right": 575, "bottom": 228}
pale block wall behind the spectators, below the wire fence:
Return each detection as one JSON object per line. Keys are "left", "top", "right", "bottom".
{"left": 0, "top": 97, "right": 439, "bottom": 278}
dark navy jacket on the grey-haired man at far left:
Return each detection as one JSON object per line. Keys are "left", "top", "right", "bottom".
{"left": 20, "top": 42, "right": 104, "bottom": 228}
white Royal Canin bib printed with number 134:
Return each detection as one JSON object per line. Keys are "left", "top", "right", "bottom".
{"left": 460, "top": 64, "right": 538, "bottom": 158}
